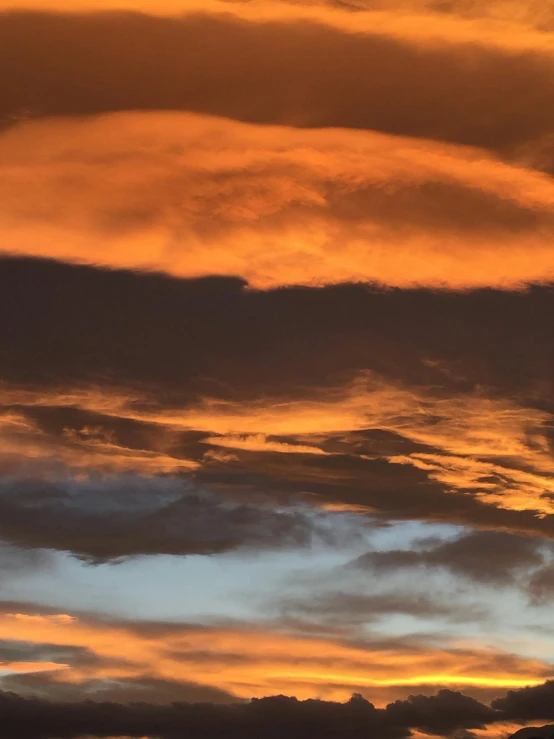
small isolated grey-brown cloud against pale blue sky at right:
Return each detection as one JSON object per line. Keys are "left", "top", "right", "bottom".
{"left": 353, "top": 531, "right": 544, "bottom": 584}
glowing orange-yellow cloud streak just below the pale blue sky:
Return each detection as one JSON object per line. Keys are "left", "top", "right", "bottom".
{"left": 0, "top": 613, "right": 549, "bottom": 700}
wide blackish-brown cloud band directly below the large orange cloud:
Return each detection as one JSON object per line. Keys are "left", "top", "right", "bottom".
{"left": 0, "top": 259, "right": 554, "bottom": 402}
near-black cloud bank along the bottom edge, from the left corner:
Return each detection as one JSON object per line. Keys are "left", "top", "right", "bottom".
{"left": 0, "top": 693, "right": 409, "bottom": 739}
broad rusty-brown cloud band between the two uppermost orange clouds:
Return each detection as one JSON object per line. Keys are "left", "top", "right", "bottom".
{"left": 0, "top": 12, "right": 554, "bottom": 155}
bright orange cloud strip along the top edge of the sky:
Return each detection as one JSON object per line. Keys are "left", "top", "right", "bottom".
{"left": 4, "top": 0, "right": 554, "bottom": 51}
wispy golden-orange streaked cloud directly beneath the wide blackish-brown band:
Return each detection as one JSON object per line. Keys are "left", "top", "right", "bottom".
{"left": 3, "top": 375, "right": 554, "bottom": 516}
